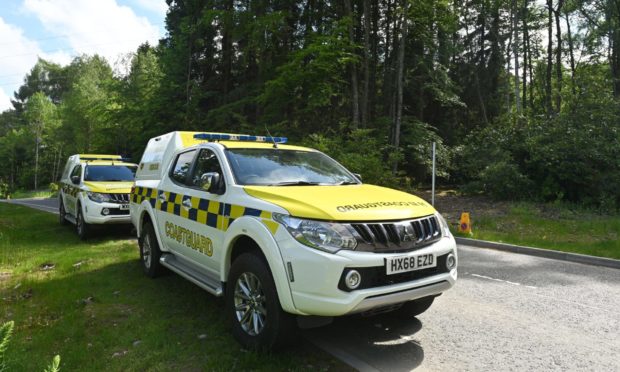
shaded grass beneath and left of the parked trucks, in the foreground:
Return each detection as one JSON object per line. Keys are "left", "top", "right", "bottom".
{"left": 0, "top": 203, "right": 348, "bottom": 371}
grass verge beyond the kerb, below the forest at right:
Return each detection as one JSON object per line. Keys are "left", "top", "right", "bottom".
{"left": 456, "top": 203, "right": 620, "bottom": 259}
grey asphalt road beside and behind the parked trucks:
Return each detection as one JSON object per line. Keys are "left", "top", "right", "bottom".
{"left": 10, "top": 199, "right": 620, "bottom": 372}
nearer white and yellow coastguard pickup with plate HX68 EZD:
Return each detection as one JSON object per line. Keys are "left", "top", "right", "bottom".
{"left": 130, "top": 132, "right": 457, "bottom": 349}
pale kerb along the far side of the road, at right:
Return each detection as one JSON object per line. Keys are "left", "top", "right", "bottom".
{"left": 454, "top": 237, "right": 620, "bottom": 269}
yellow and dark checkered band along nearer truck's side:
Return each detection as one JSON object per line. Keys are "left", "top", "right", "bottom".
{"left": 131, "top": 187, "right": 279, "bottom": 234}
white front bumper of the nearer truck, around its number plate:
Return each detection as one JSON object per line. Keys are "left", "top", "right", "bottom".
{"left": 278, "top": 235, "right": 458, "bottom": 316}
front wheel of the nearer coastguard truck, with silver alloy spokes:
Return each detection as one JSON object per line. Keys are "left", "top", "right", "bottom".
{"left": 226, "top": 253, "right": 296, "bottom": 351}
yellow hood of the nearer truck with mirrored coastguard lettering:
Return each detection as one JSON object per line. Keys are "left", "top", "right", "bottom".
{"left": 244, "top": 185, "right": 435, "bottom": 221}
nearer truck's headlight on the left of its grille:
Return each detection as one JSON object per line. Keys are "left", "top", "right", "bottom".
{"left": 273, "top": 213, "right": 357, "bottom": 253}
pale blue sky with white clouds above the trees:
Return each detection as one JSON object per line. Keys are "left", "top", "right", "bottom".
{"left": 0, "top": 0, "right": 167, "bottom": 112}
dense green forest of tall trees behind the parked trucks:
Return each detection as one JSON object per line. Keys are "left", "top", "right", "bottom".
{"left": 0, "top": 0, "right": 620, "bottom": 212}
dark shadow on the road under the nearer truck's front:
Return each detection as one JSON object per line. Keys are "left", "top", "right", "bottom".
{"left": 304, "top": 313, "right": 424, "bottom": 371}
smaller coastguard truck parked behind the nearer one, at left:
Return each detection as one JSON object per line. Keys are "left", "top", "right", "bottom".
{"left": 58, "top": 154, "right": 137, "bottom": 239}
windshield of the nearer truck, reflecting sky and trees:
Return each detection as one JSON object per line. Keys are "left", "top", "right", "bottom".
{"left": 226, "top": 149, "right": 359, "bottom": 186}
